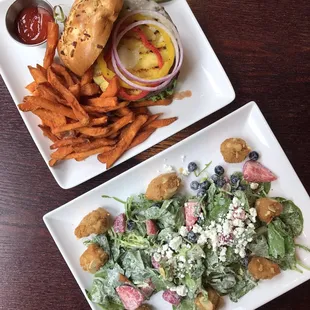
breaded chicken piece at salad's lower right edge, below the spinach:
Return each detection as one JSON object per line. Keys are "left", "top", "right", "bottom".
{"left": 248, "top": 256, "right": 281, "bottom": 280}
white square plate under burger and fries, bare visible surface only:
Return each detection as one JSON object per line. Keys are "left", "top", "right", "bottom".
{"left": 0, "top": 0, "right": 235, "bottom": 189}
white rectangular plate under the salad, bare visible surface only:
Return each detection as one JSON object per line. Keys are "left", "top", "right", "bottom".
{"left": 43, "top": 102, "right": 310, "bottom": 310}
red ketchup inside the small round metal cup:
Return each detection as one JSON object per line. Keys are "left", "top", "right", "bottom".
{"left": 15, "top": 7, "right": 53, "bottom": 44}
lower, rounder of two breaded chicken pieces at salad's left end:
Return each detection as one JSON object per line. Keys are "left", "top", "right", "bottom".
{"left": 80, "top": 243, "right": 109, "bottom": 273}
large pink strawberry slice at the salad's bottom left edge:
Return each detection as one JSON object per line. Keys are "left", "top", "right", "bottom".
{"left": 116, "top": 285, "right": 144, "bottom": 310}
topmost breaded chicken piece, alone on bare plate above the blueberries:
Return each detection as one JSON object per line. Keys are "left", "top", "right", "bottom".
{"left": 221, "top": 138, "right": 251, "bottom": 163}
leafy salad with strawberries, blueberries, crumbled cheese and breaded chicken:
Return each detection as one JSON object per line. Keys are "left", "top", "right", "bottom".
{"left": 75, "top": 141, "right": 309, "bottom": 310}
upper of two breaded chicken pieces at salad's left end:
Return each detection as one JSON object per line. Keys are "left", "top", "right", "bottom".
{"left": 74, "top": 208, "right": 111, "bottom": 238}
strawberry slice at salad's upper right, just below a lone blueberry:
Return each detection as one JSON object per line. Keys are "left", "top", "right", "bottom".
{"left": 243, "top": 160, "right": 277, "bottom": 182}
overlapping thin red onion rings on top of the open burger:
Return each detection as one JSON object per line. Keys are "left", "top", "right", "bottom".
{"left": 112, "top": 20, "right": 183, "bottom": 91}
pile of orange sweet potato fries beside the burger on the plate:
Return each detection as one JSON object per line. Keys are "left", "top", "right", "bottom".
{"left": 19, "top": 23, "right": 177, "bottom": 168}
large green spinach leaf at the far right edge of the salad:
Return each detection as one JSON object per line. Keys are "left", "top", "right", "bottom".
{"left": 275, "top": 197, "right": 304, "bottom": 237}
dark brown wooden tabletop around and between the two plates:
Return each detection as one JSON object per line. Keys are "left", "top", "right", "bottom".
{"left": 0, "top": 0, "right": 310, "bottom": 310}
